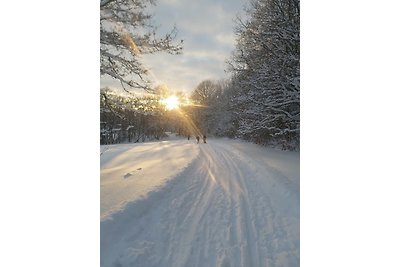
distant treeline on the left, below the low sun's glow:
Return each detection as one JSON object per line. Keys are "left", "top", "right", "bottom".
{"left": 100, "top": 88, "right": 187, "bottom": 144}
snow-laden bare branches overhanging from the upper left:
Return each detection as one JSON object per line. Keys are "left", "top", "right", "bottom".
{"left": 100, "top": 0, "right": 182, "bottom": 91}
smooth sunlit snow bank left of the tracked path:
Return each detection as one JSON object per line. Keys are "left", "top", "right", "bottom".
{"left": 100, "top": 140, "right": 199, "bottom": 220}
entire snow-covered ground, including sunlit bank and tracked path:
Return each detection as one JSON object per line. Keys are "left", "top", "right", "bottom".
{"left": 100, "top": 139, "right": 300, "bottom": 267}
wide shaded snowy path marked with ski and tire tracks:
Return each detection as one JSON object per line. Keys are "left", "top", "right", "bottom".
{"left": 101, "top": 140, "right": 299, "bottom": 267}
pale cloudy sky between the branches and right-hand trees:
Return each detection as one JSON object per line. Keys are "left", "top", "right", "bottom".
{"left": 101, "top": 0, "right": 247, "bottom": 93}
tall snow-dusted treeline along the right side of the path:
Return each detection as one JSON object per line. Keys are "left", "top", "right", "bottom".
{"left": 192, "top": 0, "right": 300, "bottom": 150}
